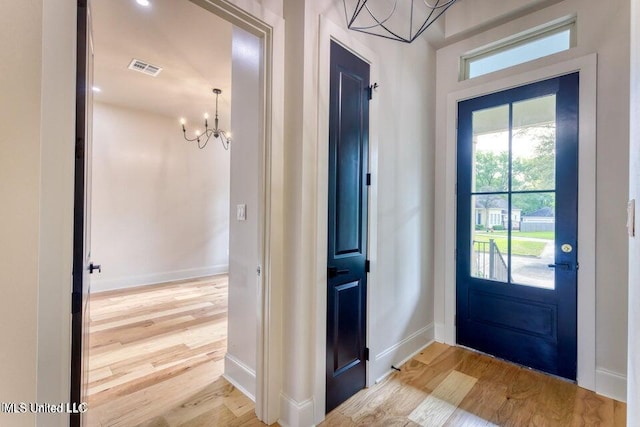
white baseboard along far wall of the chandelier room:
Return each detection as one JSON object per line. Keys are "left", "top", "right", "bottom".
{"left": 91, "top": 264, "right": 229, "bottom": 293}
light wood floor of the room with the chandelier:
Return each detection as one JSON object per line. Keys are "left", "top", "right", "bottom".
{"left": 86, "top": 276, "right": 263, "bottom": 427}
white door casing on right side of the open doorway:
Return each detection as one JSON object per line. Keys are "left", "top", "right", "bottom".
{"left": 191, "top": 0, "right": 285, "bottom": 424}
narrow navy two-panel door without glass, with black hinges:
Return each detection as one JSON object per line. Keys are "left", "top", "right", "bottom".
{"left": 326, "top": 42, "right": 369, "bottom": 412}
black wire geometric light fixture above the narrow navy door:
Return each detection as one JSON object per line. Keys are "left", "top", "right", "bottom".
{"left": 342, "top": 0, "right": 456, "bottom": 43}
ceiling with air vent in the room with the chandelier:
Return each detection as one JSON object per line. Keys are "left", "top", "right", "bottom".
{"left": 92, "top": 0, "right": 232, "bottom": 129}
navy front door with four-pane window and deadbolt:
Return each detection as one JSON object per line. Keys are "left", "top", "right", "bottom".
{"left": 456, "top": 73, "right": 579, "bottom": 380}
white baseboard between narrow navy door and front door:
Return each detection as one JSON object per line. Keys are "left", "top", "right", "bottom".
{"left": 370, "top": 323, "right": 434, "bottom": 383}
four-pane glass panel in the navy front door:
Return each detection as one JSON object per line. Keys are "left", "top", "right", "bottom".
{"left": 470, "top": 95, "right": 556, "bottom": 289}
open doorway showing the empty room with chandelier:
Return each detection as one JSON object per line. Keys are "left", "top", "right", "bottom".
{"left": 74, "top": 0, "right": 266, "bottom": 425}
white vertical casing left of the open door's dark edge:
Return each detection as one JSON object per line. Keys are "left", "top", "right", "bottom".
{"left": 36, "top": 0, "right": 77, "bottom": 426}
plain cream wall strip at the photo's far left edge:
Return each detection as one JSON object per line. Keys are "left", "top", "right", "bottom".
{"left": 0, "top": 1, "right": 43, "bottom": 426}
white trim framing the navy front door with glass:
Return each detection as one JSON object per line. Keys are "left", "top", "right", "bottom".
{"left": 435, "top": 53, "right": 596, "bottom": 394}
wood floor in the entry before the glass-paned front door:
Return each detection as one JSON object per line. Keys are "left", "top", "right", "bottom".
{"left": 320, "top": 343, "right": 626, "bottom": 427}
